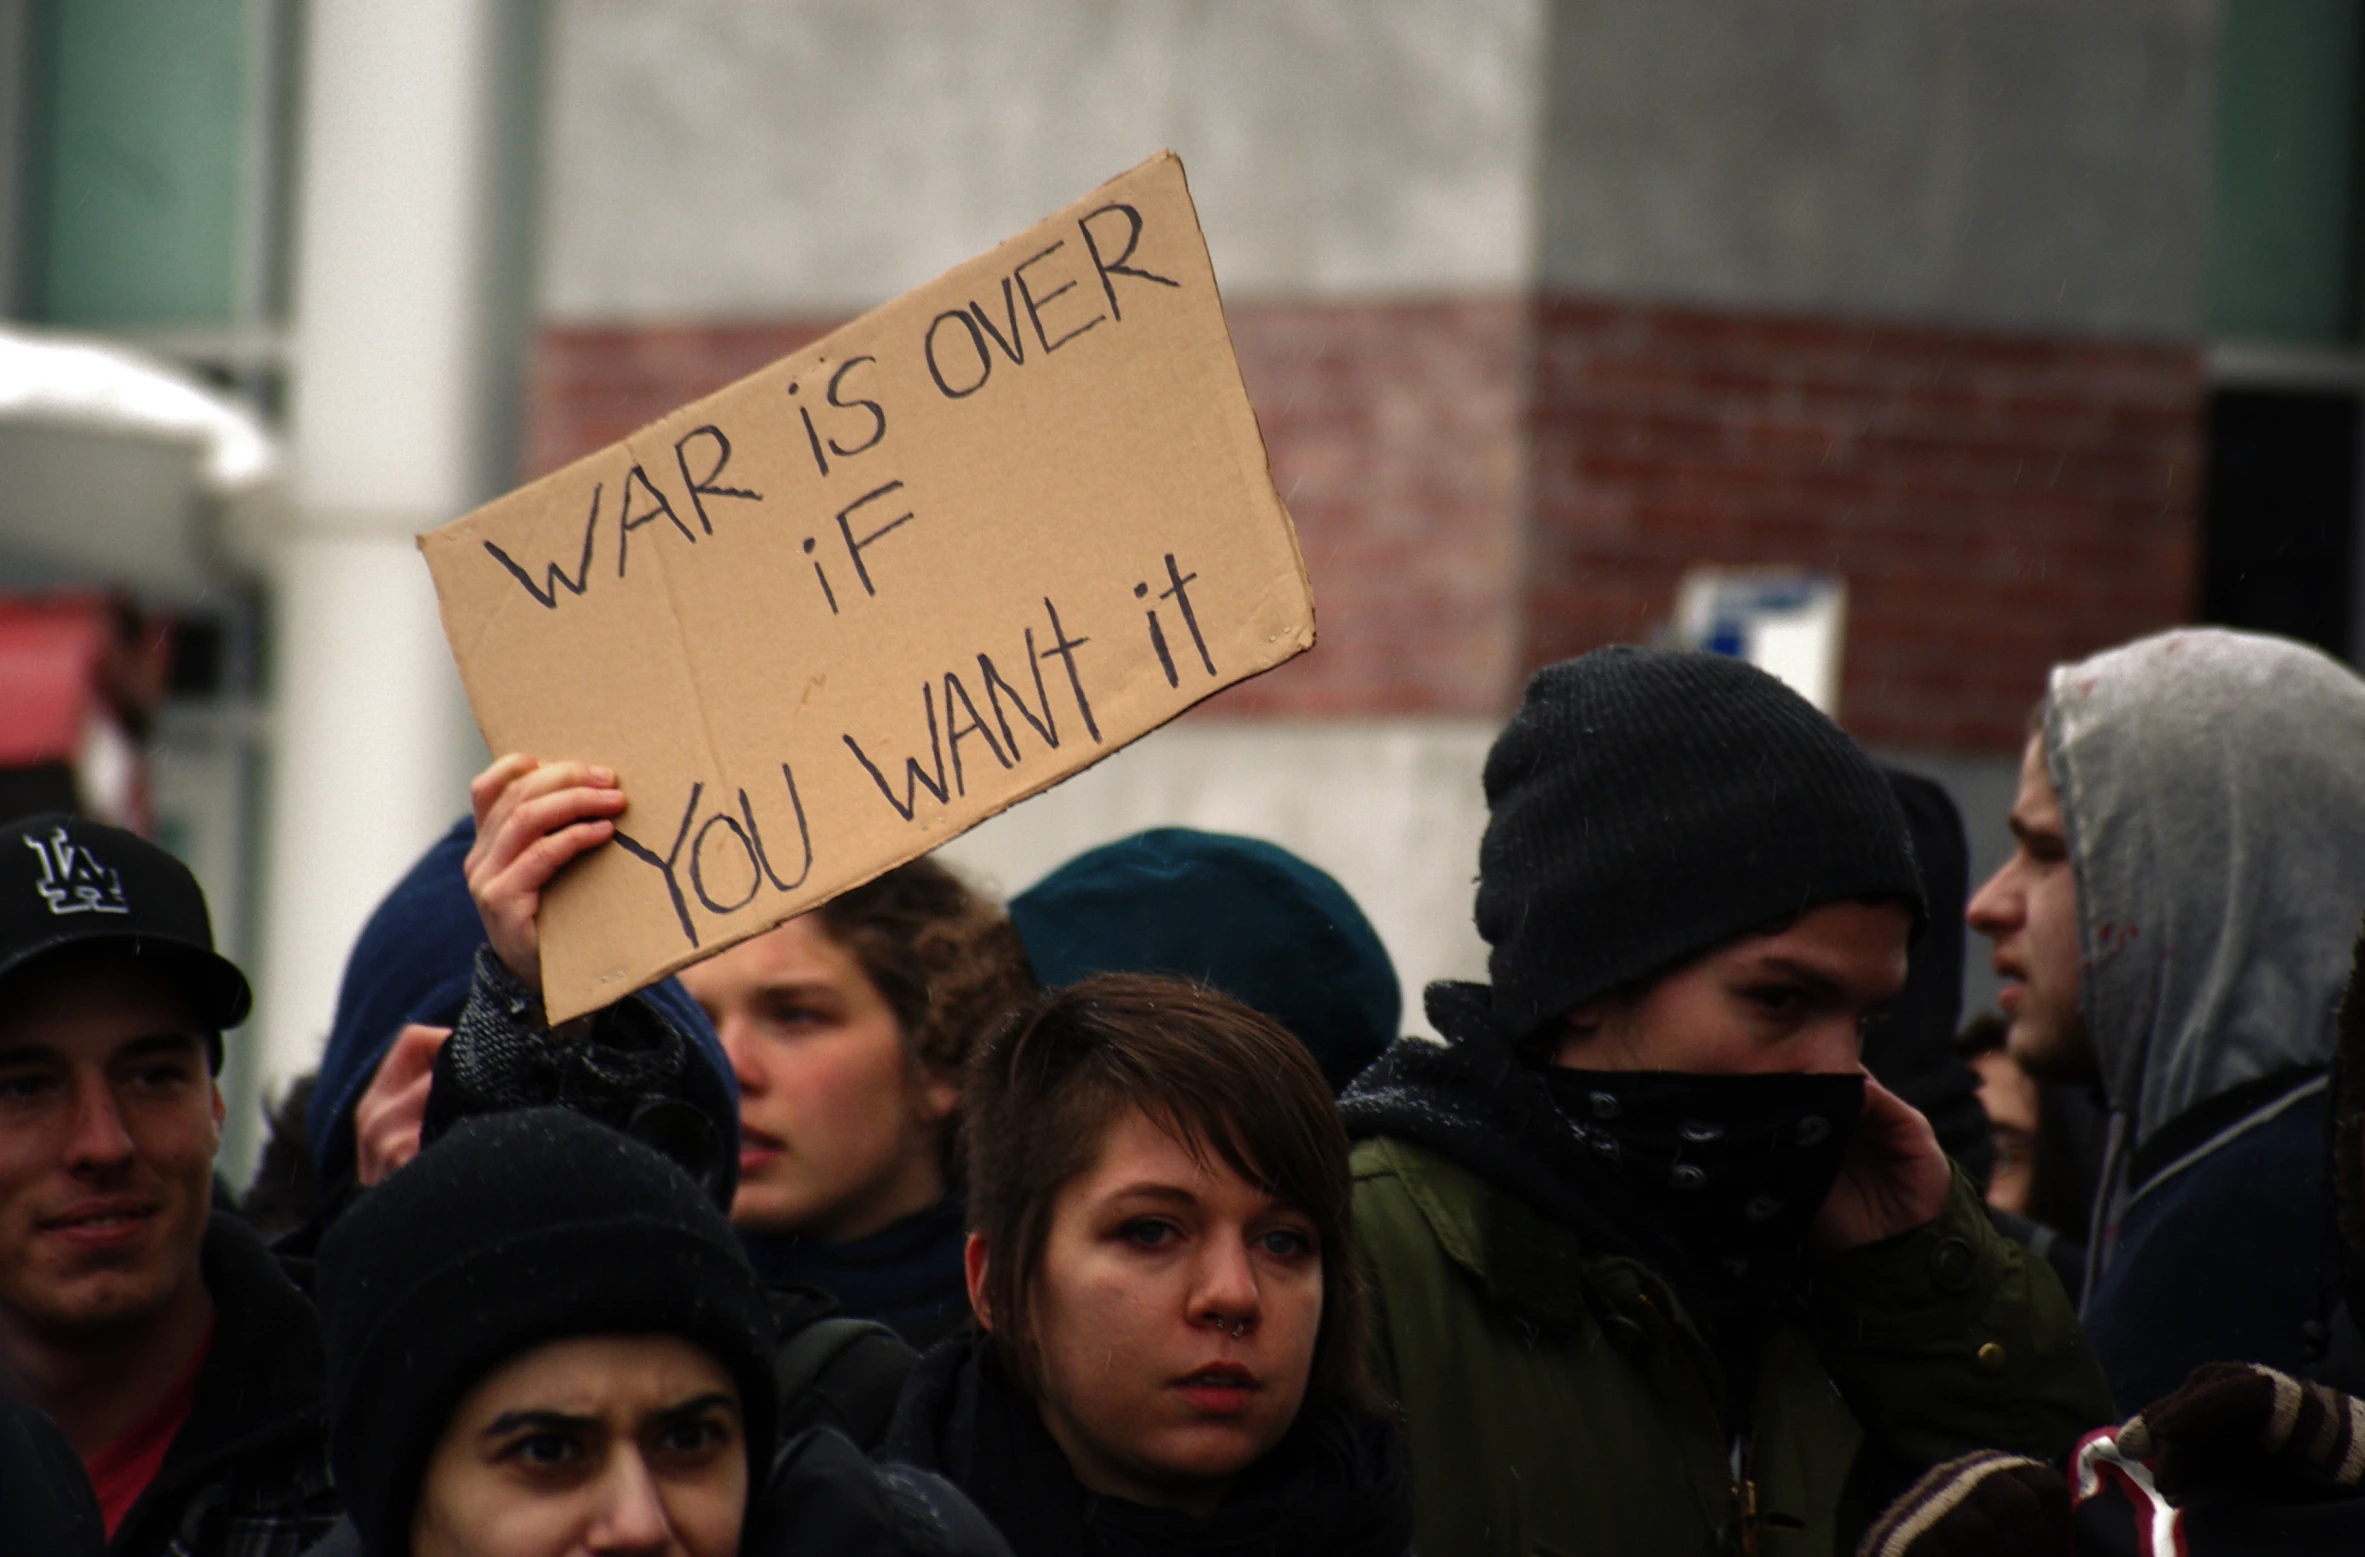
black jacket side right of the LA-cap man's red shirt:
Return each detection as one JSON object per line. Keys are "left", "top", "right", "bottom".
{"left": 109, "top": 1212, "right": 326, "bottom": 1555}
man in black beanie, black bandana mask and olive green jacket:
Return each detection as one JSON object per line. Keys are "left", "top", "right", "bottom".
{"left": 1343, "top": 648, "right": 2112, "bottom": 1557}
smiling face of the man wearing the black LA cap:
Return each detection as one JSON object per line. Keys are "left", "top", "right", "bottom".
{"left": 0, "top": 956, "right": 222, "bottom": 1335}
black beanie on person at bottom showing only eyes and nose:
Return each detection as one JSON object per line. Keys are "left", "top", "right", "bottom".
{"left": 317, "top": 1107, "right": 778, "bottom": 1557}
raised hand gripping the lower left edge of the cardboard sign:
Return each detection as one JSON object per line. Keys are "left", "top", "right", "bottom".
{"left": 464, "top": 752, "right": 624, "bottom": 994}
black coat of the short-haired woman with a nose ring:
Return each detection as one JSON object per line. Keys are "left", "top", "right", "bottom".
{"left": 880, "top": 1335, "right": 1412, "bottom": 1557}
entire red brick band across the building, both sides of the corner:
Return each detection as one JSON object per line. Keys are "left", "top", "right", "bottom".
{"left": 530, "top": 298, "right": 2202, "bottom": 752}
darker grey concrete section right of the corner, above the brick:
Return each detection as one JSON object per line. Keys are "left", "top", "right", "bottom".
{"left": 1540, "top": 0, "right": 2216, "bottom": 338}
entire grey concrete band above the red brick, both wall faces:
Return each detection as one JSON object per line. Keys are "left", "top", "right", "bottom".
{"left": 542, "top": 0, "right": 2216, "bottom": 338}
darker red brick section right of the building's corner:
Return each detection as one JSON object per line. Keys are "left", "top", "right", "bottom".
{"left": 1523, "top": 301, "right": 2202, "bottom": 752}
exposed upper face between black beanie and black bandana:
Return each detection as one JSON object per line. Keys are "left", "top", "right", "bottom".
{"left": 1554, "top": 889, "right": 1913, "bottom": 1074}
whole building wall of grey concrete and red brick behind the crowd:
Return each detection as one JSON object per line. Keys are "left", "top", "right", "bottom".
{"left": 530, "top": 0, "right": 2216, "bottom": 1050}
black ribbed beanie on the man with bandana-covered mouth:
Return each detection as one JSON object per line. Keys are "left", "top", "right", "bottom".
{"left": 1478, "top": 648, "right": 1925, "bottom": 1041}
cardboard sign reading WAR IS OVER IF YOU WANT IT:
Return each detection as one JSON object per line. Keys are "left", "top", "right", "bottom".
{"left": 419, "top": 154, "right": 1315, "bottom": 1022}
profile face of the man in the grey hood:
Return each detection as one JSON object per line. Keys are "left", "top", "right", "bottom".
{"left": 1963, "top": 736, "right": 2098, "bottom": 1081}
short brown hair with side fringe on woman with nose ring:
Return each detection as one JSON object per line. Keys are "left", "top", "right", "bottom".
{"left": 963, "top": 973, "right": 1384, "bottom": 1413}
